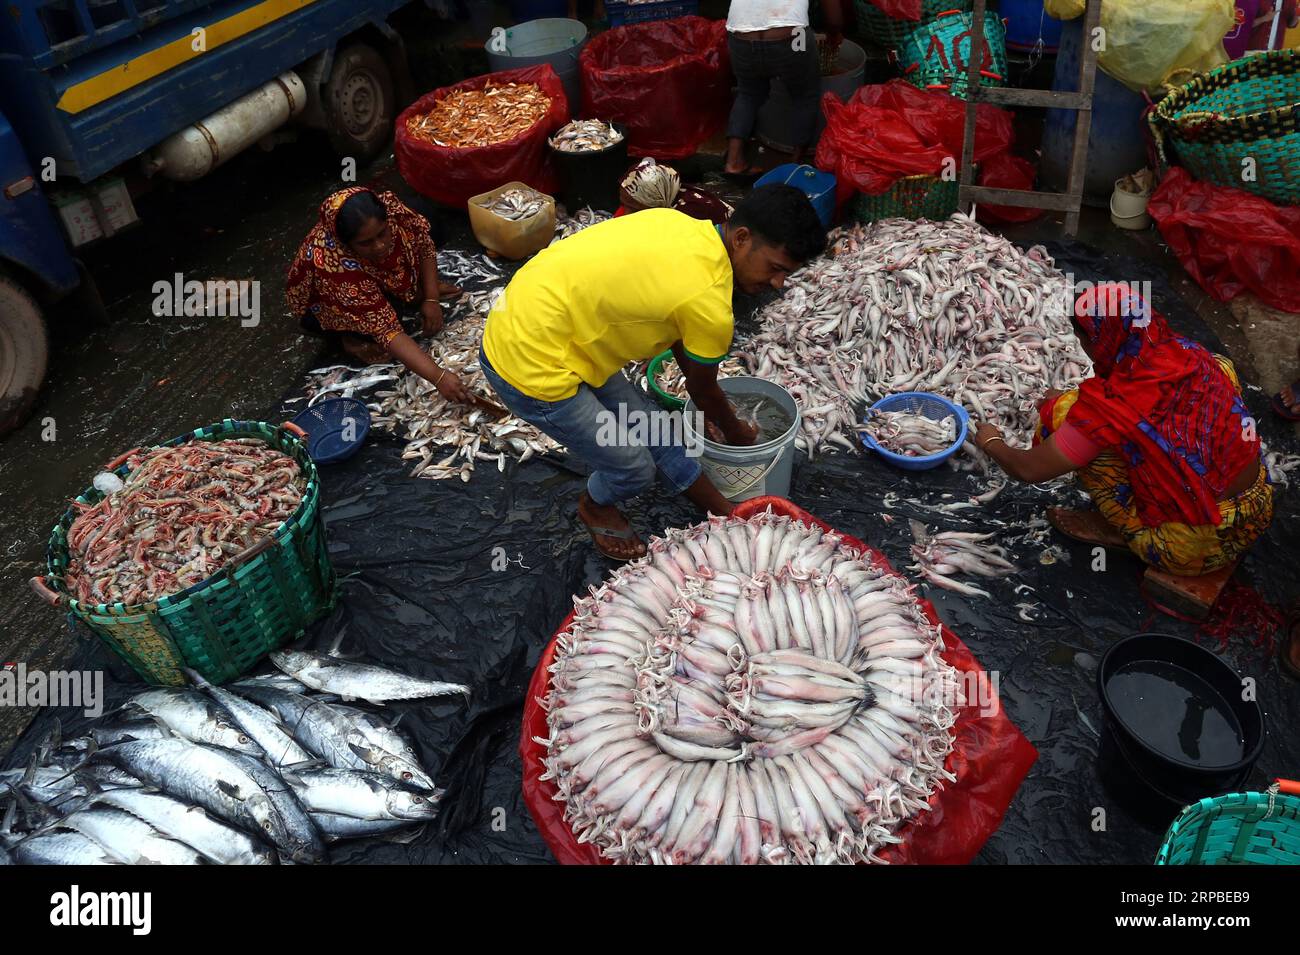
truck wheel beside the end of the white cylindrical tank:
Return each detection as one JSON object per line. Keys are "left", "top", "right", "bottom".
{"left": 321, "top": 43, "right": 398, "bottom": 162}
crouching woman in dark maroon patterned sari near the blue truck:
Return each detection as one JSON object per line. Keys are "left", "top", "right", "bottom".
{"left": 285, "top": 186, "right": 471, "bottom": 401}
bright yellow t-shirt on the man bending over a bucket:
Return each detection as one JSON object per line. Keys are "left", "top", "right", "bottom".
{"left": 484, "top": 209, "right": 735, "bottom": 401}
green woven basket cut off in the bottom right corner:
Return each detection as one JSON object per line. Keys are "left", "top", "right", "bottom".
{"left": 1156, "top": 780, "right": 1300, "bottom": 865}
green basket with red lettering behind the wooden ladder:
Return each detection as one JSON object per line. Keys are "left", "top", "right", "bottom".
{"left": 898, "top": 12, "right": 1008, "bottom": 99}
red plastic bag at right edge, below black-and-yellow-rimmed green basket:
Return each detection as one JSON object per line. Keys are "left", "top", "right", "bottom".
{"left": 1147, "top": 166, "right": 1300, "bottom": 312}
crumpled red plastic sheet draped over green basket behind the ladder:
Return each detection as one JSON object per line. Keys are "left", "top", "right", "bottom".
{"left": 816, "top": 79, "right": 1015, "bottom": 201}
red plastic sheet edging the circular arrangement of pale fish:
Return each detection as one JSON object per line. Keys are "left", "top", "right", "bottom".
{"left": 519, "top": 498, "right": 1039, "bottom": 865}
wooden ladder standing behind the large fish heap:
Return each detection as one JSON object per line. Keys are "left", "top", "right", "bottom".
{"left": 957, "top": 0, "right": 1101, "bottom": 235}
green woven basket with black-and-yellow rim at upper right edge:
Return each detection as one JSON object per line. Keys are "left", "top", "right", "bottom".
{"left": 1148, "top": 49, "right": 1300, "bottom": 205}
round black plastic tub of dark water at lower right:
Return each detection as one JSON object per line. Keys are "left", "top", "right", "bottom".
{"left": 1097, "top": 634, "right": 1265, "bottom": 806}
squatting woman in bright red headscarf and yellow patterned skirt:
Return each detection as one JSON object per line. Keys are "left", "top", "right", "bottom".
{"left": 975, "top": 285, "right": 1273, "bottom": 576}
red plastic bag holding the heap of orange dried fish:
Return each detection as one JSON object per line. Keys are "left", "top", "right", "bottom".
{"left": 393, "top": 64, "right": 569, "bottom": 205}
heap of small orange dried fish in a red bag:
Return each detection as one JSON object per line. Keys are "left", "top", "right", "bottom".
{"left": 407, "top": 83, "right": 551, "bottom": 148}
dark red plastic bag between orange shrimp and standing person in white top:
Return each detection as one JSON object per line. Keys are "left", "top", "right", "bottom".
{"left": 579, "top": 17, "right": 731, "bottom": 160}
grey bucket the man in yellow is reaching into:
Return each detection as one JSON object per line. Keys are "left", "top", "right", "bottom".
{"left": 683, "top": 378, "right": 800, "bottom": 503}
